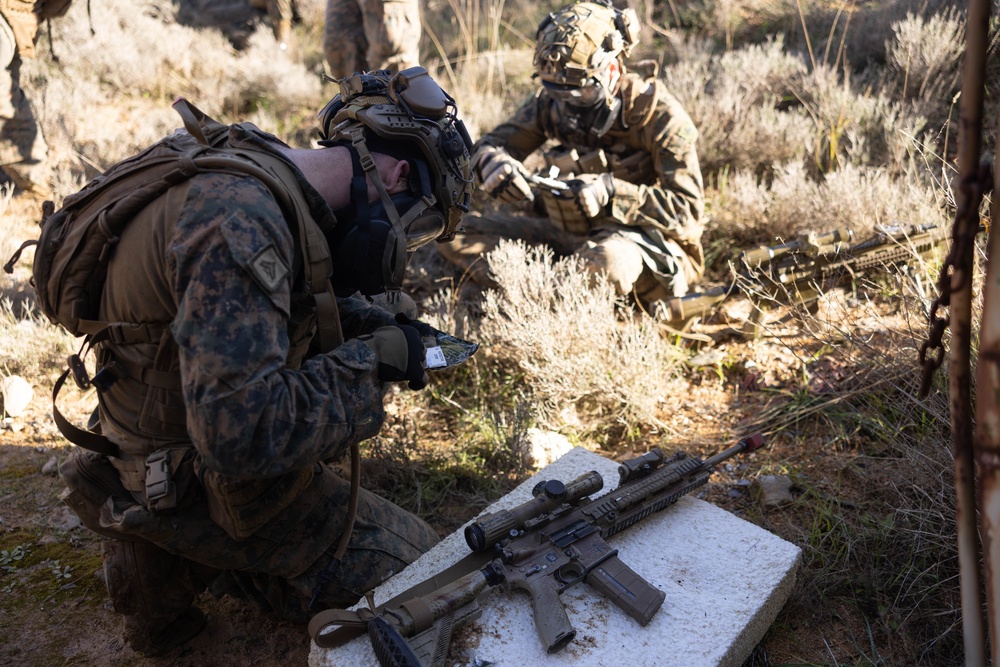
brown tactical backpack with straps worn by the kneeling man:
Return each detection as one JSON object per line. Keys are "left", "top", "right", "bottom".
{"left": 4, "top": 99, "right": 343, "bottom": 456}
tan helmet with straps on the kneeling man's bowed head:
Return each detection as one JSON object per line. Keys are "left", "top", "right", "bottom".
{"left": 319, "top": 67, "right": 474, "bottom": 245}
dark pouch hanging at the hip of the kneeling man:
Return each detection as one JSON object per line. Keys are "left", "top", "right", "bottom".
{"left": 195, "top": 460, "right": 316, "bottom": 540}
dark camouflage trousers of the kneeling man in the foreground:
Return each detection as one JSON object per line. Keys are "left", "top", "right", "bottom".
{"left": 60, "top": 449, "right": 438, "bottom": 650}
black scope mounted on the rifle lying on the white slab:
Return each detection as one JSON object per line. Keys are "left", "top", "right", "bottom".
{"left": 465, "top": 470, "right": 604, "bottom": 551}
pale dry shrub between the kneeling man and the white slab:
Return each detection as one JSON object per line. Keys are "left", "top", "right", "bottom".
{"left": 479, "top": 242, "right": 683, "bottom": 425}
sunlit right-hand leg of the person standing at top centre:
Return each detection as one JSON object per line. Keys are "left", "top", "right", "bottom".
{"left": 361, "top": 0, "right": 420, "bottom": 71}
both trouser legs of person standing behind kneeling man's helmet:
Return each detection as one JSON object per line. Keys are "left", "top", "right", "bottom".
{"left": 323, "top": 0, "right": 420, "bottom": 78}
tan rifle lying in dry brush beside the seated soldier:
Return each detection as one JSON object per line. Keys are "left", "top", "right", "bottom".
{"left": 665, "top": 224, "right": 985, "bottom": 324}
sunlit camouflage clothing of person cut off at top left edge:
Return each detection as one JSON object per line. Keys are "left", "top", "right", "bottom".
{"left": 0, "top": 0, "right": 71, "bottom": 196}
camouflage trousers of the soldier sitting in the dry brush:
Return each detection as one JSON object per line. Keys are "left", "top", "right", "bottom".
{"left": 437, "top": 212, "right": 699, "bottom": 305}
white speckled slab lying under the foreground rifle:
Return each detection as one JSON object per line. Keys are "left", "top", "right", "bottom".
{"left": 309, "top": 447, "right": 800, "bottom": 667}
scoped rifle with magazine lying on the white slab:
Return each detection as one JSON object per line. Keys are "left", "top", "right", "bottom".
{"left": 309, "top": 434, "right": 764, "bottom": 667}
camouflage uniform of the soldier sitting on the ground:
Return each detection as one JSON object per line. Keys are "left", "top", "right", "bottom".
{"left": 439, "top": 73, "right": 704, "bottom": 303}
